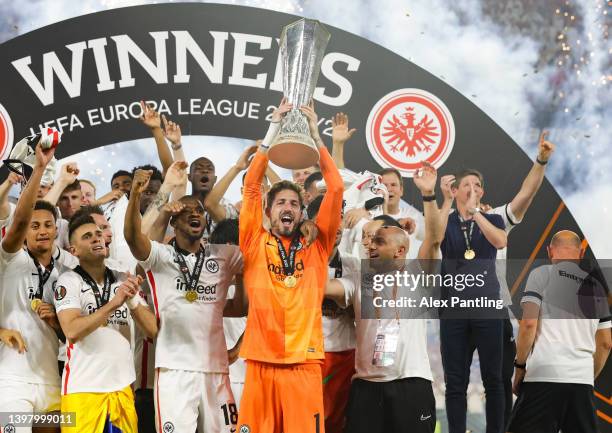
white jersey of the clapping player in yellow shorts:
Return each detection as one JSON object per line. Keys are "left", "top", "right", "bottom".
{"left": 54, "top": 269, "right": 146, "bottom": 395}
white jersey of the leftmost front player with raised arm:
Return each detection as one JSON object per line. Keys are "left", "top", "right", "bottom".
{"left": 0, "top": 243, "right": 73, "bottom": 386}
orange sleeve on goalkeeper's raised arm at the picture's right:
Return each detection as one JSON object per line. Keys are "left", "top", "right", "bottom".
{"left": 316, "top": 147, "right": 344, "bottom": 255}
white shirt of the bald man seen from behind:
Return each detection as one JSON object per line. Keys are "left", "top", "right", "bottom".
{"left": 521, "top": 262, "right": 611, "bottom": 385}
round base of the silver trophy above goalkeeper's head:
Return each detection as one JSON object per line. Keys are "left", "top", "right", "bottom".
{"left": 268, "top": 134, "right": 319, "bottom": 170}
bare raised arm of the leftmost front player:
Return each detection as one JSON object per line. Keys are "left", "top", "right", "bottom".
{"left": 2, "top": 143, "right": 55, "bottom": 253}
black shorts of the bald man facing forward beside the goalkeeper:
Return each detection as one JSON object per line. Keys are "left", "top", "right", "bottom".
{"left": 344, "top": 377, "right": 436, "bottom": 433}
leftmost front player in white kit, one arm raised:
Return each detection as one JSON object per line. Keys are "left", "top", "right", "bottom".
{"left": 0, "top": 144, "right": 65, "bottom": 433}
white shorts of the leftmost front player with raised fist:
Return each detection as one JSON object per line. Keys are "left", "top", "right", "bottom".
{"left": 0, "top": 379, "right": 60, "bottom": 433}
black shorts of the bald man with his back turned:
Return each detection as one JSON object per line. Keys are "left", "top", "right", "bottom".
{"left": 506, "top": 382, "right": 597, "bottom": 433}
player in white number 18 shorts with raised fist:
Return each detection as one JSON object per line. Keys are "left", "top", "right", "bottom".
{"left": 124, "top": 170, "right": 242, "bottom": 433}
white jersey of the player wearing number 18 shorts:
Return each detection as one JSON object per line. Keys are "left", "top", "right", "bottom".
{"left": 139, "top": 241, "right": 242, "bottom": 373}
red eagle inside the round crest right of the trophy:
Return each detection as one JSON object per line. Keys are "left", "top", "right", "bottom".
{"left": 382, "top": 106, "right": 440, "bottom": 156}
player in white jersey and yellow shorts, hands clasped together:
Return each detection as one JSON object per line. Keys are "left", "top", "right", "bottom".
{"left": 54, "top": 214, "right": 157, "bottom": 433}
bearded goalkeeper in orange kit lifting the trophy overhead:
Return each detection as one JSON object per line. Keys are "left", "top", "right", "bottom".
{"left": 238, "top": 100, "right": 343, "bottom": 433}
